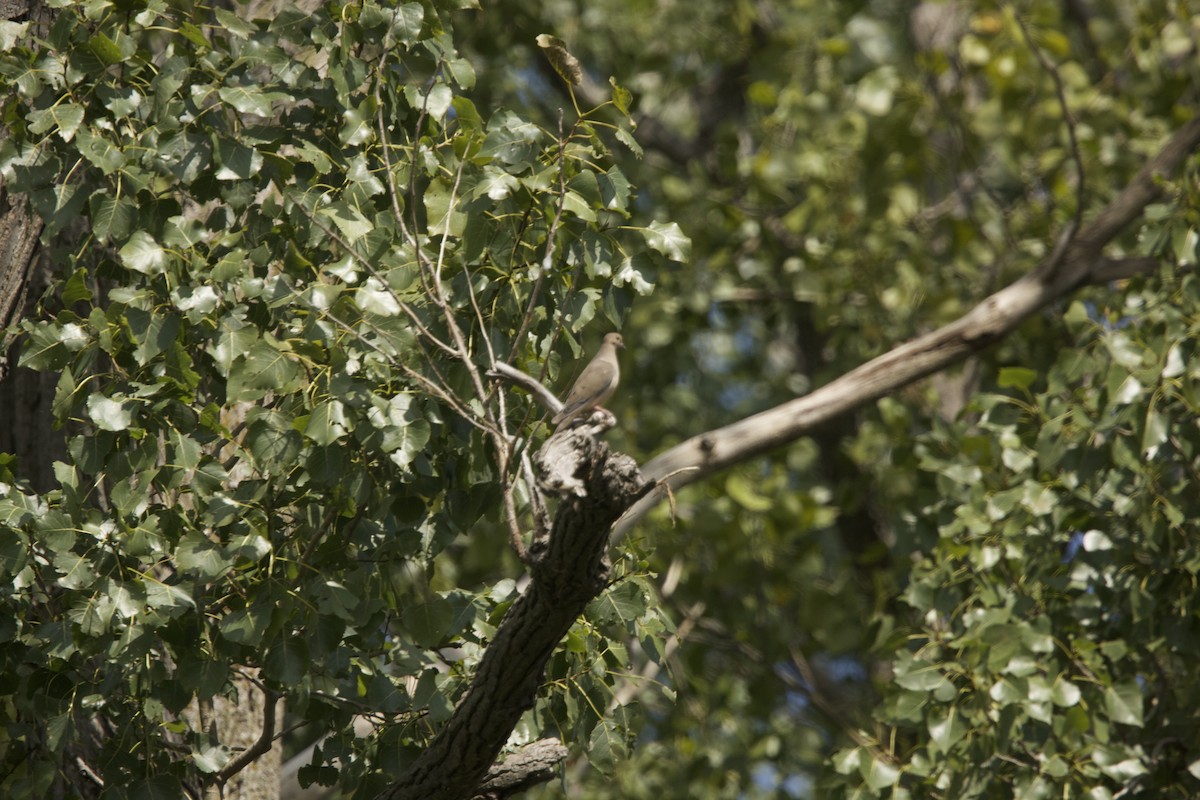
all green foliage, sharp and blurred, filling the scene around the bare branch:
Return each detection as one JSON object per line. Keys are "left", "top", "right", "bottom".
{"left": 0, "top": 0, "right": 1200, "bottom": 799}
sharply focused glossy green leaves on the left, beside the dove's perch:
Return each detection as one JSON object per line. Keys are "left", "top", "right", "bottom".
{"left": 0, "top": 2, "right": 686, "bottom": 796}
